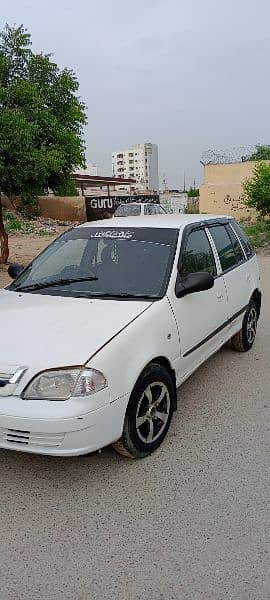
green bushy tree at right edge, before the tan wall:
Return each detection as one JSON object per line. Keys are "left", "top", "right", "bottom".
{"left": 243, "top": 162, "right": 270, "bottom": 217}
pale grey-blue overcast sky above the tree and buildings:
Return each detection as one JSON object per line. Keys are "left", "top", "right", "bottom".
{"left": 0, "top": 0, "right": 270, "bottom": 188}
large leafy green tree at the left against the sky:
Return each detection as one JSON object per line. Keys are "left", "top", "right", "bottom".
{"left": 0, "top": 25, "right": 86, "bottom": 263}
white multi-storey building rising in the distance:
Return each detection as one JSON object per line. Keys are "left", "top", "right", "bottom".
{"left": 112, "top": 142, "right": 159, "bottom": 193}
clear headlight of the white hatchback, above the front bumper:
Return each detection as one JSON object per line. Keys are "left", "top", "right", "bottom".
{"left": 22, "top": 368, "right": 108, "bottom": 400}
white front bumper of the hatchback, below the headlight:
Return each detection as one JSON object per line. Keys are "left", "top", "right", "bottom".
{"left": 0, "top": 395, "right": 128, "bottom": 456}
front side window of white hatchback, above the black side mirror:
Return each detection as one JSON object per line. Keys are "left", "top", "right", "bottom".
{"left": 180, "top": 229, "right": 217, "bottom": 278}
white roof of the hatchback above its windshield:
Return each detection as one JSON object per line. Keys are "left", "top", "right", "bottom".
{"left": 79, "top": 214, "right": 232, "bottom": 229}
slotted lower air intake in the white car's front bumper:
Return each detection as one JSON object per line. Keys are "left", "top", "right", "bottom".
{"left": 0, "top": 429, "right": 65, "bottom": 448}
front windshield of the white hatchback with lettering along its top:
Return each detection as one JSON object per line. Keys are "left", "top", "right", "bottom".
{"left": 8, "top": 226, "right": 178, "bottom": 299}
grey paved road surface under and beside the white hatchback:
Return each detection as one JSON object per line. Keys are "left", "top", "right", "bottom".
{"left": 0, "top": 257, "right": 270, "bottom": 600}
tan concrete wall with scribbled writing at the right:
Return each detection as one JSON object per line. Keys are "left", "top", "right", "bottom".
{"left": 200, "top": 161, "right": 270, "bottom": 221}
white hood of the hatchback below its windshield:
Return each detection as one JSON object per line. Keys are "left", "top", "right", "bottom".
{"left": 0, "top": 289, "right": 150, "bottom": 369}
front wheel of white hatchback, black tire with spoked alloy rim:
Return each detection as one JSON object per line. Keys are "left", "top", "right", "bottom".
{"left": 113, "top": 363, "right": 175, "bottom": 458}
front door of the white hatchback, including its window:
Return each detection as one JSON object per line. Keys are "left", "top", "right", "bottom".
{"left": 170, "top": 227, "right": 228, "bottom": 383}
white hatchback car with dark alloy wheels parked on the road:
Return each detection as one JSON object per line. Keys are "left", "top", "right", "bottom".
{"left": 0, "top": 215, "right": 261, "bottom": 458}
